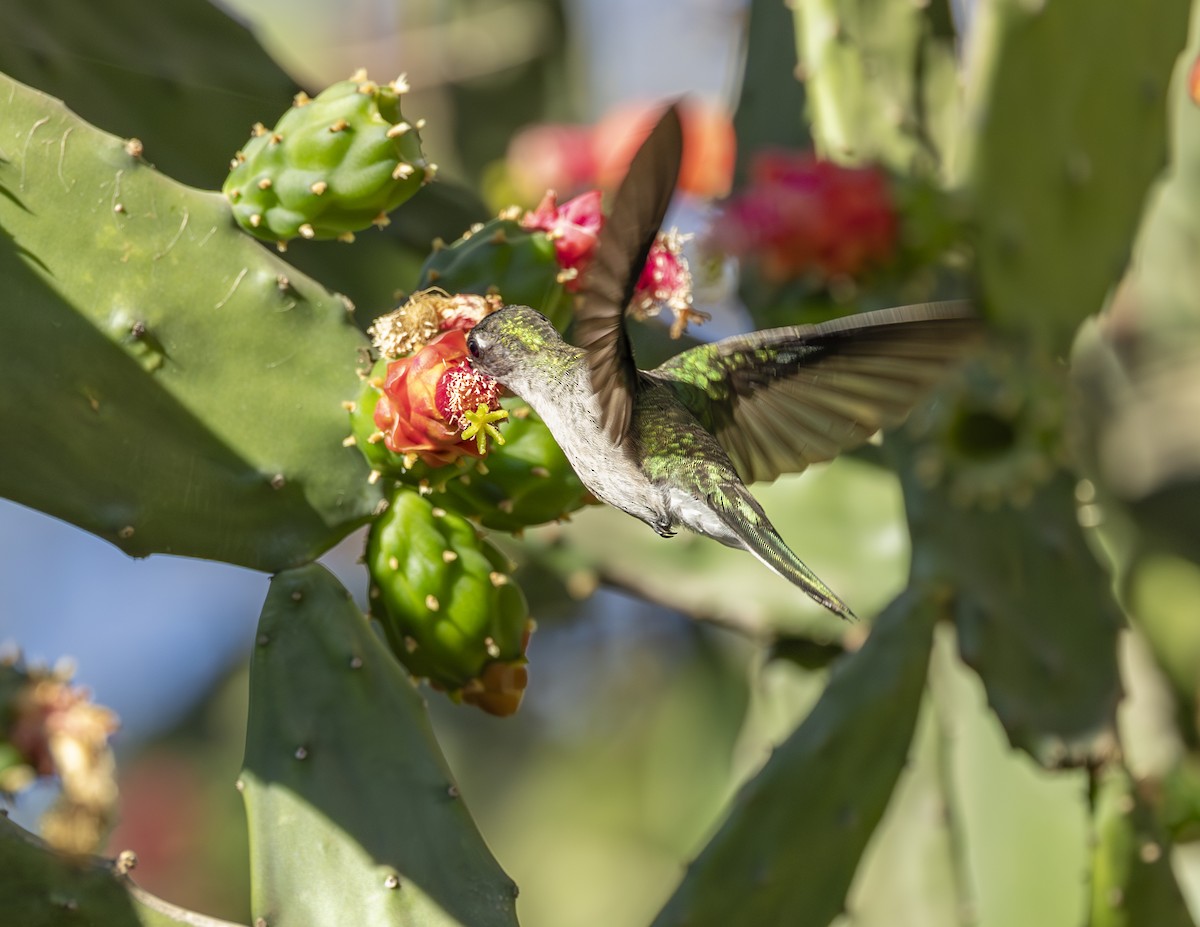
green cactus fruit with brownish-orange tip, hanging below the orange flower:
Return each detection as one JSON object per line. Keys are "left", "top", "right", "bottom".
{"left": 366, "top": 486, "right": 533, "bottom": 716}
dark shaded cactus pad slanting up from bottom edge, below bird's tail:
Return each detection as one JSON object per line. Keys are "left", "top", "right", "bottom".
{"left": 654, "top": 590, "right": 938, "bottom": 927}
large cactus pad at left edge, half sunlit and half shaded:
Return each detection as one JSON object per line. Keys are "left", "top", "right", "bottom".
{"left": 0, "top": 77, "right": 379, "bottom": 570}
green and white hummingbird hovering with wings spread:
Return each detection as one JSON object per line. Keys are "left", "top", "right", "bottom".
{"left": 467, "top": 106, "right": 978, "bottom": 618}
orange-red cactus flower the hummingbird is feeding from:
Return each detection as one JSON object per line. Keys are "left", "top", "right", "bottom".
{"left": 374, "top": 328, "right": 503, "bottom": 467}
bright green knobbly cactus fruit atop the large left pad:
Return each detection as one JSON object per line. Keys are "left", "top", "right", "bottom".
{"left": 222, "top": 72, "right": 437, "bottom": 243}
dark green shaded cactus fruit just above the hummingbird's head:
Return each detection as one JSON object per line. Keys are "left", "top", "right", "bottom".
{"left": 416, "top": 215, "right": 570, "bottom": 330}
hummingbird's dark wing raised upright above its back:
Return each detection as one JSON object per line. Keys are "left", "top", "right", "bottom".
{"left": 574, "top": 106, "right": 683, "bottom": 443}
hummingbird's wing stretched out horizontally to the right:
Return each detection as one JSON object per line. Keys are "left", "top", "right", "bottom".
{"left": 648, "top": 301, "right": 982, "bottom": 483}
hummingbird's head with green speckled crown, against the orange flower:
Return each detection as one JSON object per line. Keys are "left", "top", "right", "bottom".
{"left": 467, "top": 306, "right": 566, "bottom": 395}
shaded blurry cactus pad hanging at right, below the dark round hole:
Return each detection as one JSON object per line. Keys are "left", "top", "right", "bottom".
{"left": 902, "top": 458, "right": 1122, "bottom": 766}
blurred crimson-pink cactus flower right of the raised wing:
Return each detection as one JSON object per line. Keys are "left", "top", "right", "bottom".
{"left": 710, "top": 151, "right": 899, "bottom": 280}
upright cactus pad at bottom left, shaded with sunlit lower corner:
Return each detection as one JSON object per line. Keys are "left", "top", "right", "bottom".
{"left": 240, "top": 566, "right": 516, "bottom": 927}
